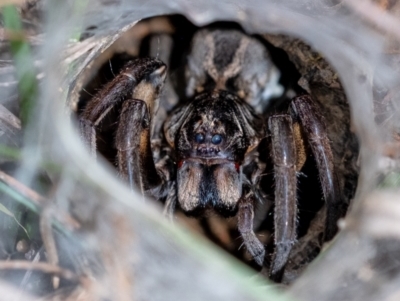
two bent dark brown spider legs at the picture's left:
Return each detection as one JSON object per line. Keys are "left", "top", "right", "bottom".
{"left": 80, "top": 58, "right": 166, "bottom": 192}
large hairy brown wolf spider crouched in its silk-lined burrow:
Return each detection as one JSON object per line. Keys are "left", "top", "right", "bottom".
{"left": 79, "top": 29, "right": 341, "bottom": 279}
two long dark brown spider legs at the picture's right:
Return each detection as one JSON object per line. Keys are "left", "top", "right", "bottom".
{"left": 268, "top": 95, "right": 341, "bottom": 280}
